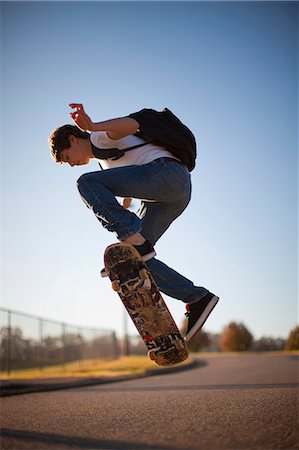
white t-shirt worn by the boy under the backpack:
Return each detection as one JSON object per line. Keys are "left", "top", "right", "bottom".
{"left": 90, "top": 131, "right": 177, "bottom": 169}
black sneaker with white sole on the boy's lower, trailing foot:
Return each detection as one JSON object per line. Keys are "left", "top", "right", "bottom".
{"left": 185, "top": 292, "right": 219, "bottom": 341}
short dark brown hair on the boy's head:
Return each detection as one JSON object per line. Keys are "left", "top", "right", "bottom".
{"left": 49, "top": 124, "right": 90, "bottom": 162}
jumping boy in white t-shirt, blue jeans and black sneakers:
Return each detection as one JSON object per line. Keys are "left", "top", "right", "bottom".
{"left": 49, "top": 103, "right": 219, "bottom": 340}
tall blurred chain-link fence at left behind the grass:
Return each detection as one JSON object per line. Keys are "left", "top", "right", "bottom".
{"left": 0, "top": 308, "right": 119, "bottom": 374}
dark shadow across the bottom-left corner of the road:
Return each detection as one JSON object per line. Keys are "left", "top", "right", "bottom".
{"left": 1, "top": 428, "right": 170, "bottom": 450}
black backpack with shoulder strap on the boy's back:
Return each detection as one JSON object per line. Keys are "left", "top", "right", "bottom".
{"left": 91, "top": 108, "right": 196, "bottom": 172}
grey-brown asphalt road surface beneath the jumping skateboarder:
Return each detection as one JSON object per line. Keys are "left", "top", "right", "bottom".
{"left": 1, "top": 354, "right": 299, "bottom": 450}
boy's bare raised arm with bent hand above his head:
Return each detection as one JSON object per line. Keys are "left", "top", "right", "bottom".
{"left": 69, "top": 103, "right": 139, "bottom": 140}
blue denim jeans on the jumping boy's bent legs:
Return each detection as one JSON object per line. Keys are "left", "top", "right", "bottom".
{"left": 78, "top": 160, "right": 209, "bottom": 304}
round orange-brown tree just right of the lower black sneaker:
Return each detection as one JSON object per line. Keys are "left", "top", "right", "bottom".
{"left": 220, "top": 322, "right": 253, "bottom": 352}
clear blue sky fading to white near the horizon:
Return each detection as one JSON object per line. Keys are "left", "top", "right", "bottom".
{"left": 1, "top": 2, "right": 298, "bottom": 338}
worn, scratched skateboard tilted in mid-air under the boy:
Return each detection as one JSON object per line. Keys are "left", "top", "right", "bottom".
{"left": 104, "top": 243, "right": 188, "bottom": 366}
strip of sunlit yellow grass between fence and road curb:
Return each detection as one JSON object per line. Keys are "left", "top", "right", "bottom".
{"left": 0, "top": 356, "right": 188, "bottom": 380}
